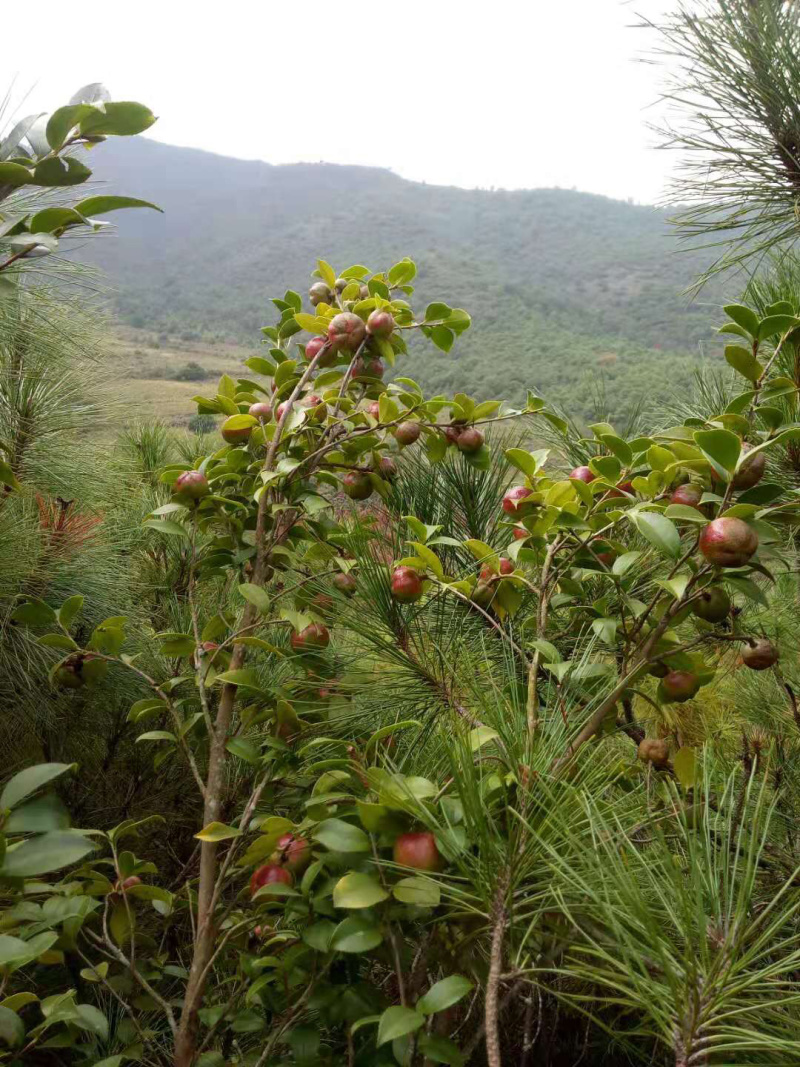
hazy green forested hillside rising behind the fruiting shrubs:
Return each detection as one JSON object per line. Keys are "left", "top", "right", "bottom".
{"left": 92, "top": 139, "right": 719, "bottom": 414}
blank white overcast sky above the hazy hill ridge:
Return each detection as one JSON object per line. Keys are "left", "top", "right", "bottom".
{"left": 3, "top": 0, "right": 674, "bottom": 202}
